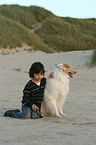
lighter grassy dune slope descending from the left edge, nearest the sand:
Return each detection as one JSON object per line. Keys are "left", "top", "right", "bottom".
{"left": 0, "top": 15, "right": 47, "bottom": 51}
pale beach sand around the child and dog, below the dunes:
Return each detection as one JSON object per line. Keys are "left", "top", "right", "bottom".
{"left": 0, "top": 50, "right": 96, "bottom": 145}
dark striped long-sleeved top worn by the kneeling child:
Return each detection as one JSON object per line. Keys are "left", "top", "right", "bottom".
{"left": 21, "top": 78, "right": 46, "bottom": 108}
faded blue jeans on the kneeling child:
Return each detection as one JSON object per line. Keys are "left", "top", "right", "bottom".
{"left": 12, "top": 104, "right": 38, "bottom": 119}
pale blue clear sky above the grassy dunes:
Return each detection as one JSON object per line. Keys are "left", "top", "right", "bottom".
{"left": 0, "top": 0, "right": 96, "bottom": 18}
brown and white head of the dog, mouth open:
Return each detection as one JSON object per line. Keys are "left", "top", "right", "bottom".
{"left": 56, "top": 64, "right": 76, "bottom": 78}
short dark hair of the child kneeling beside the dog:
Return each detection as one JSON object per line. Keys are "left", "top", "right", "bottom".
{"left": 29, "top": 62, "right": 45, "bottom": 78}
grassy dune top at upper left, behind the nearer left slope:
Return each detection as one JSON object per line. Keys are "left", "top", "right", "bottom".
{"left": 0, "top": 5, "right": 53, "bottom": 29}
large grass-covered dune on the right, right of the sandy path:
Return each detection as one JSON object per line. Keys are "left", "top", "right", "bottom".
{"left": 36, "top": 17, "right": 96, "bottom": 51}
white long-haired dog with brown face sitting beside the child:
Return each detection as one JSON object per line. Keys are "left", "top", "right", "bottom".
{"left": 41, "top": 64, "right": 76, "bottom": 117}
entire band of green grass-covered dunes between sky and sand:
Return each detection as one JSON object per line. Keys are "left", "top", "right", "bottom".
{"left": 0, "top": 5, "right": 96, "bottom": 53}
